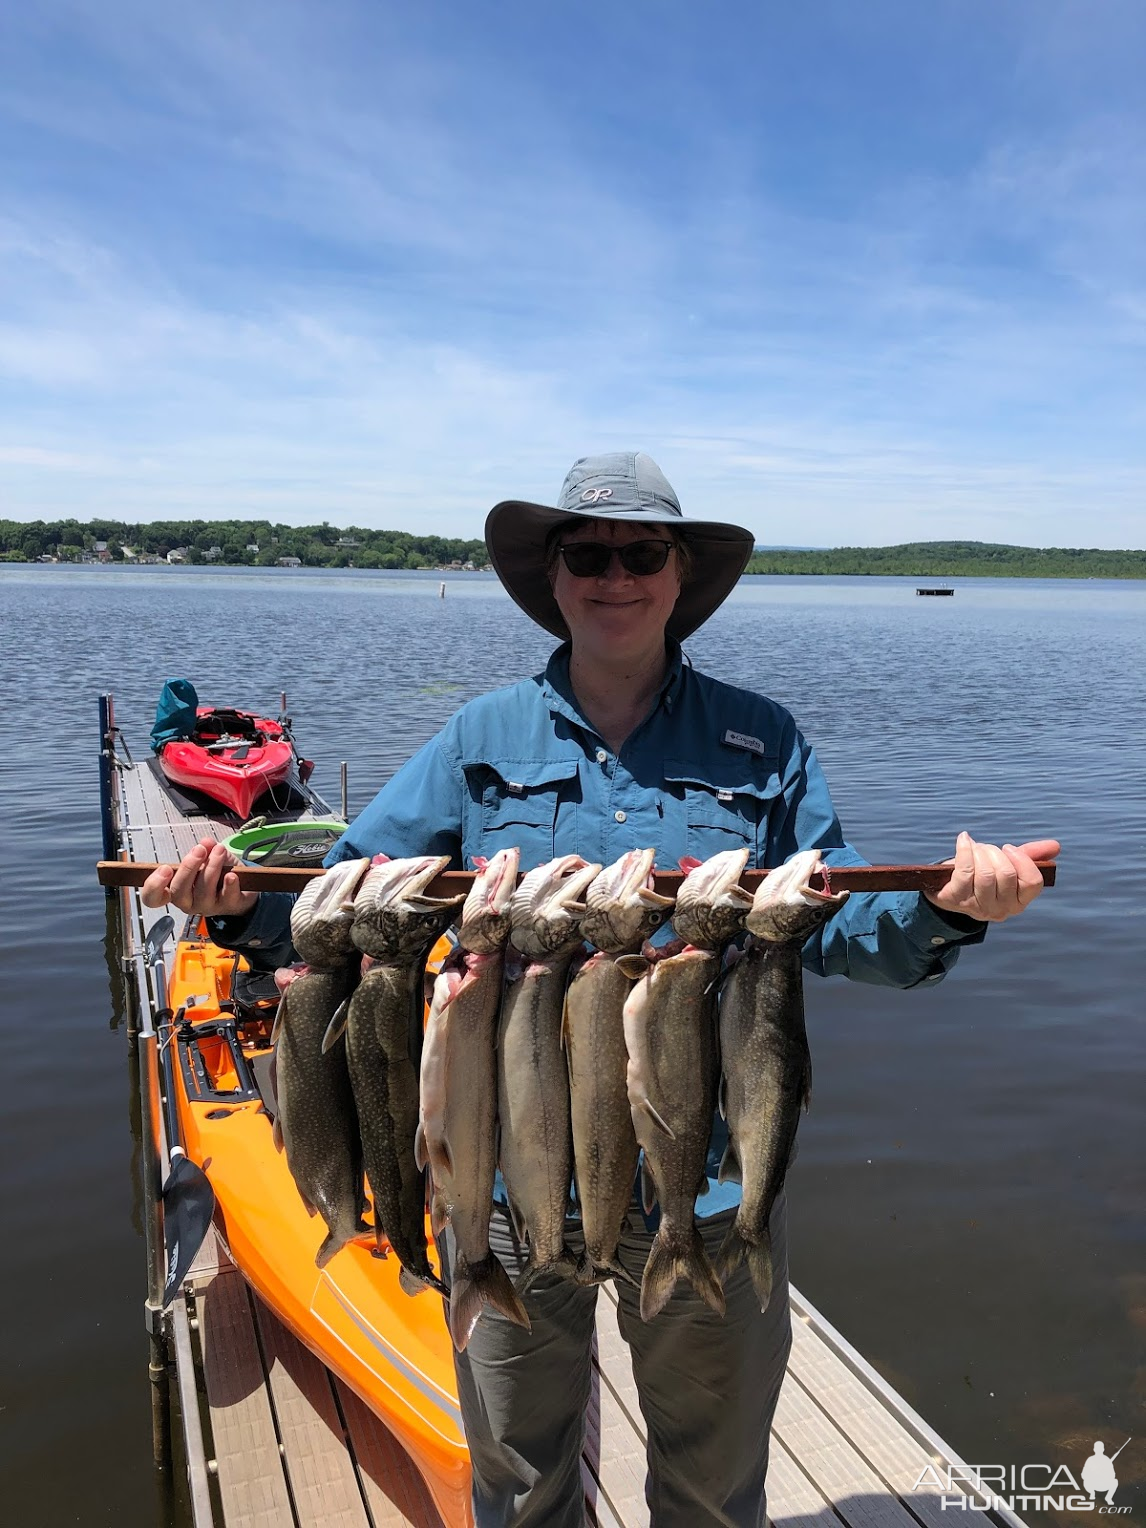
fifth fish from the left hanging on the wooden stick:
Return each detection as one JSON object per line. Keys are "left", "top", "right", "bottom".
{"left": 564, "top": 850, "right": 672, "bottom": 1284}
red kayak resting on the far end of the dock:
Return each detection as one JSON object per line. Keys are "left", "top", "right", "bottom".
{"left": 159, "top": 706, "right": 313, "bottom": 821}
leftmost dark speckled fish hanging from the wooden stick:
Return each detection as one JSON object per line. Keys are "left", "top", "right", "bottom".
{"left": 275, "top": 860, "right": 368, "bottom": 1268}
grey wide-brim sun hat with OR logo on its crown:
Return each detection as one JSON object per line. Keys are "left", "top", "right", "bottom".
{"left": 486, "top": 451, "right": 753, "bottom": 642}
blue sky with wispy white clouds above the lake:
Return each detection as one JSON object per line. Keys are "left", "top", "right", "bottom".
{"left": 0, "top": 0, "right": 1146, "bottom": 547}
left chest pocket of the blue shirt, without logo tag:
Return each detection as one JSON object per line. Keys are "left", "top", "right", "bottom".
{"left": 465, "top": 759, "right": 581, "bottom": 869}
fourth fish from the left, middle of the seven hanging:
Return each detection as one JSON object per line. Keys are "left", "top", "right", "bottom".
{"left": 498, "top": 854, "right": 601, "bottom": 1293}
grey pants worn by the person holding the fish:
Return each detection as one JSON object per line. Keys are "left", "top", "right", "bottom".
{"left": 443, "top": 1195, "right": 792, "bottom": 1528}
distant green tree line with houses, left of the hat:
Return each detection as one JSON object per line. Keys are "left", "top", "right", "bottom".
{"left": 0, "top": 520, "right": 489, "bottom": 568}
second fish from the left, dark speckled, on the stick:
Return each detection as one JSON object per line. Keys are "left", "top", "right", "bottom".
{"left": 345, "top": 856, "right": 465, "bottom": 1294}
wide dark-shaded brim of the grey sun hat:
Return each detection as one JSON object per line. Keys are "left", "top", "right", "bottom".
{"left": 486, "top": 498, "right": 753, "bottom": 642}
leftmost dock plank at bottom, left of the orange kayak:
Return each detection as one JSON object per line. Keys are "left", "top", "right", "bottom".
{"left": 196, "top": 1274, "right": 296, "bottom": 1528}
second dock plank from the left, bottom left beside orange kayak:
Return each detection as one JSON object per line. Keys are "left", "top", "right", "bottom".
{"left": 254, "top": 1297, "right": 368, "bottom": 1528}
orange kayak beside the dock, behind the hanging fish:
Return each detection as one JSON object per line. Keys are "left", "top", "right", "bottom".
{"left": 168, "top": 916, "right": 474, "bottom": 1528}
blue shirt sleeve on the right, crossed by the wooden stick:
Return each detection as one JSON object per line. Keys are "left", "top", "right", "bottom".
{"left": 773, "top": 724, "right": 987, "bottom": 987}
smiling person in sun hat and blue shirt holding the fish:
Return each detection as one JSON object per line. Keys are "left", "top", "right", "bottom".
{"left": 144, "top": 452, "right": 1059, "bottom": 1528}
